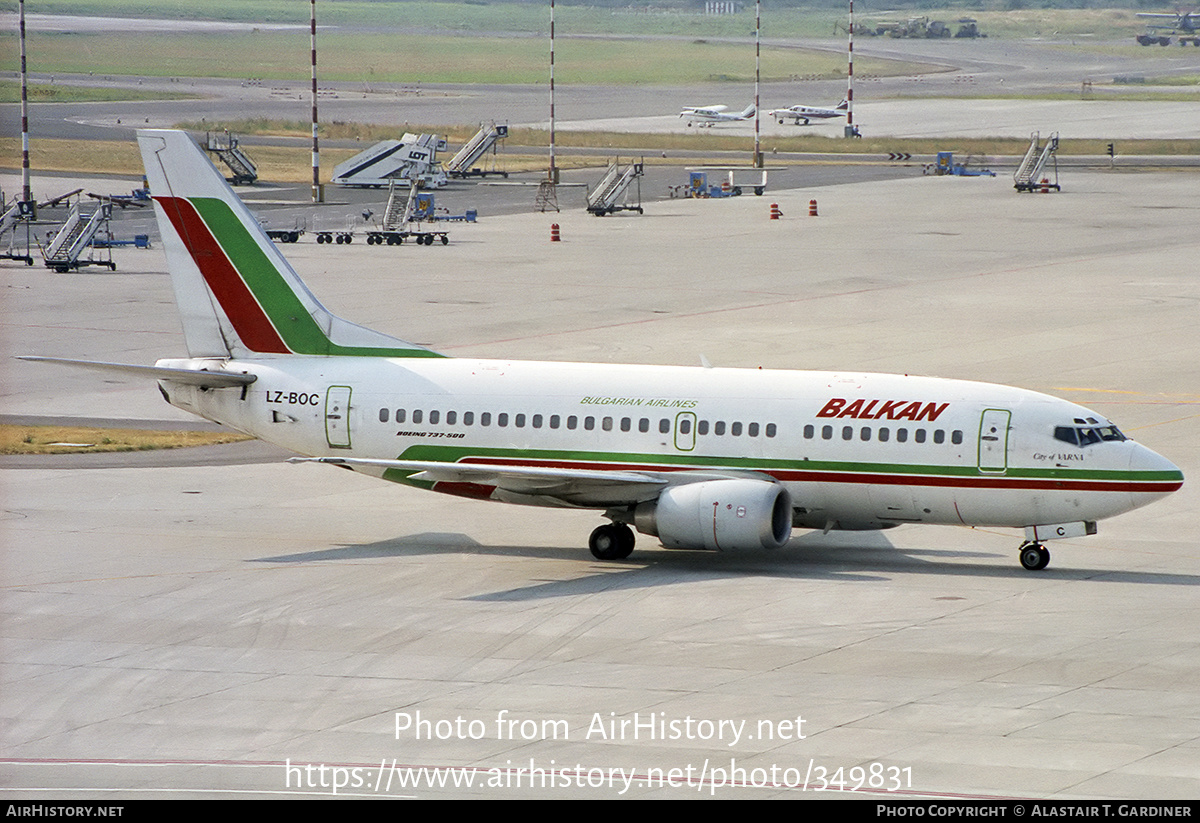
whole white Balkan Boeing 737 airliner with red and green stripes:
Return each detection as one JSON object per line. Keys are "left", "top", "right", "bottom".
{"left": 16, "top": 131, "right": 1183, "bottom": 570}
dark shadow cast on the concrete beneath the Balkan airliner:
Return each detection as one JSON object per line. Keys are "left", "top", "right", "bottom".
{"left": 253, "top": 533, "right": 1200, "bottom": 601}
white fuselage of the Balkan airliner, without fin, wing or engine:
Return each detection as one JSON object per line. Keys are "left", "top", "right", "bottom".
{"left": 154, "top": 356, "right": 1182, "bottom": 529}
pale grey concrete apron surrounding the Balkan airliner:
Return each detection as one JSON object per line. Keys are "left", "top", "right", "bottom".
{"left": 0, "top": 170, "right": 1200, "bottom": 800}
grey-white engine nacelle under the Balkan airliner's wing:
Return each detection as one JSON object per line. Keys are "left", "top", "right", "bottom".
{"left": 634, "top": 479, "right": 792, "bottom": 549}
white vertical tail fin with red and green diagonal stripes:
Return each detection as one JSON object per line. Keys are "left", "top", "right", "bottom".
{"left": 138, "top": 130, "right": 442, "bottom": 358}
